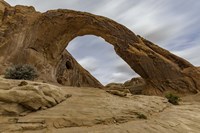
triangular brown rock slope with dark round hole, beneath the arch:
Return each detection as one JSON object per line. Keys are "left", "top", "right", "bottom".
{"left": 56, "top": 50, "right": 103, "bottom": 88}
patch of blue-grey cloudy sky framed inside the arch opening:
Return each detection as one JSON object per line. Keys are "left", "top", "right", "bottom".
{"left": 66, "top": 35, "right": 139, "bottom": 85}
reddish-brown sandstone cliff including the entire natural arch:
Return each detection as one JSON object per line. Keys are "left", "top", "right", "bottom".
{"left": 0, "top": 3, "right": 200, "bottom": 94}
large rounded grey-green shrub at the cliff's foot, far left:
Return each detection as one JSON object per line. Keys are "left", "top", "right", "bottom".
{"left": 5, "top": 64, "right": 38, "bottom": 80}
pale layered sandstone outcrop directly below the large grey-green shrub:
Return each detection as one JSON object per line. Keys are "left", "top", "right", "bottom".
{"left": 0, "top": 78, "right": 67, "bottom": 115}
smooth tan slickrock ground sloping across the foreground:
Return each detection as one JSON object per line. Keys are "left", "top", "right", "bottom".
{"left": 0, "top": 87, "right": 200, "bottom": 133}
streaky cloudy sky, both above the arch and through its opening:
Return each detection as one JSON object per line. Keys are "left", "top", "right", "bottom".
{"left": 6, "top": 0, "right": 200, "bottom": 84}
